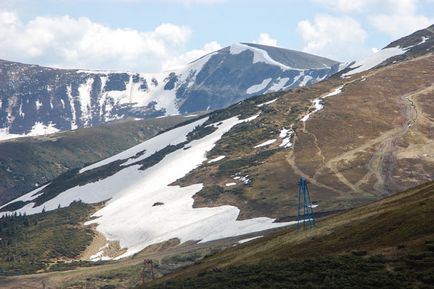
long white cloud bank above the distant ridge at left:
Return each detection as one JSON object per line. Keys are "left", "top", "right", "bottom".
{"left": 0, "top": 11, "right": 213, "bottom": 71}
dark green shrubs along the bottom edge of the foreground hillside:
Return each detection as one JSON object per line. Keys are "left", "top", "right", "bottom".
{"left": 150, "top": 251, "right": 434, "bottom": 289}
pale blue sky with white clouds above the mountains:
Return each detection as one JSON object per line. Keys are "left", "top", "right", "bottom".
{"left": 0, "top": 0, "right": 434, "bottom": 72}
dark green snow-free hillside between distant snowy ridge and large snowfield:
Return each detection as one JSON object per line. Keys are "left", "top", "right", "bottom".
{"left": 0, "top": 116, "right": 193, "bottom": 205}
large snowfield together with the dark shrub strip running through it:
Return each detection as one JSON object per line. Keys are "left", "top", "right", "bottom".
{"left": 2, "top": 106, "right": 294, "bottom": 258}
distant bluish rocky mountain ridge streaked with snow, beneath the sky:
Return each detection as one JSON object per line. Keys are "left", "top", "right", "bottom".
{"left": 0, "top": 44, "right": 339, "bottom": 139}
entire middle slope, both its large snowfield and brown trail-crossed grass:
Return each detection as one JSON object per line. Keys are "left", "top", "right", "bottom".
{"left": 0, "top": 24, "right": 434, "bottom": 264}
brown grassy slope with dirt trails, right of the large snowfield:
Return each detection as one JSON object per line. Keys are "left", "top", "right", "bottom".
{"left": 178, "top": 54, "right": 434, "bottom": 219}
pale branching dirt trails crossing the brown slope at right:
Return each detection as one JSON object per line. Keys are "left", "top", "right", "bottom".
{"left": 288, "top": 68, "right": 434, "bottom": 194}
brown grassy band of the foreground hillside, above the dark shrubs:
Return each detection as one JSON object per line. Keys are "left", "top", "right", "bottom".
{"left": 148, "top": 182, "right": 434, "bottom": 283}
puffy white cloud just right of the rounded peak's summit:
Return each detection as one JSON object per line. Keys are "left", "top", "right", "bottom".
{"left": 297, "top": 15, "right": 369, "bottom": 61}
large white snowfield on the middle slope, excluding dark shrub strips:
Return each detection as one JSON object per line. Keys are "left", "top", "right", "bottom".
{"left": 0, "top": 116, "right": 291, "bottom": 259}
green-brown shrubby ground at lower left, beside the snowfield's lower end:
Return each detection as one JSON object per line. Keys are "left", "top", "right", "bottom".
{"left": 0, "top": 202, "right": 95, "bottom": 275}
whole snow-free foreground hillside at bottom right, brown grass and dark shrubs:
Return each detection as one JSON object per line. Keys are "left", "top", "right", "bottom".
{"left": 147, "top": 182, "right": 434, "bottom": 288}
